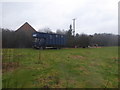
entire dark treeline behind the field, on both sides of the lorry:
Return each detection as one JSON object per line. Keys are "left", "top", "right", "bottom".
{"left": 2, "top": 28, "right": 120, "bottom": 48}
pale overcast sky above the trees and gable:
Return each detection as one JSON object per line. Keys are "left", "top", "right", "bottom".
{"left": 0, "top": 0, "right": 119, "bottom": 34}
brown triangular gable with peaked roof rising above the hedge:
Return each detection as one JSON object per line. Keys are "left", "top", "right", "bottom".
{"left": 15, "top": 22, "right": 36, "bottom": 32}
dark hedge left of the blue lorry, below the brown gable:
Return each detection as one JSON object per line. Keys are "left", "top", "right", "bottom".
{"left": 2, "top": 29, "right": 33, "bottom": 48}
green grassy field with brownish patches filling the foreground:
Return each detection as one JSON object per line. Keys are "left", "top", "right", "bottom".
{"left": 2, "top": 47, "right": 118, "bottom": 88}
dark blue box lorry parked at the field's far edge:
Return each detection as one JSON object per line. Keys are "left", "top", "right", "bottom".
{"left": 33, "top": 32, "right": 66, "bottom": 49}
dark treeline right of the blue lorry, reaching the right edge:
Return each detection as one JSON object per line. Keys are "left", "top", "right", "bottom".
{"left": 62, "top": 29, "right": 120, "bottom": 48}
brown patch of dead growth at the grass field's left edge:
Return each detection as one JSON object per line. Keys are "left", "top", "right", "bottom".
{"left": 2, "top": 62, "right": 19, "bottom": 73}
